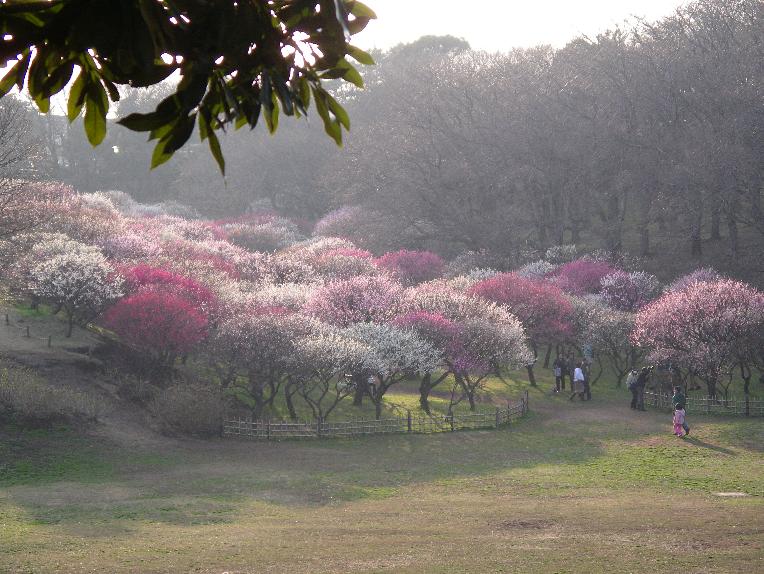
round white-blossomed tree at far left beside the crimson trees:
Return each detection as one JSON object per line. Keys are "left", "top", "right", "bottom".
{"left": 29, "top": 237, "right": 122, "bottom": 337}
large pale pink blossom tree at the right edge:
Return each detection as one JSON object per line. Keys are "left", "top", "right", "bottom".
{"left": 632, "top": 279, "right": 764, "bottom": 397}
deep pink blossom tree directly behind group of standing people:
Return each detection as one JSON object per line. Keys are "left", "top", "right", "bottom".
{"left": 468, "top": 273, "right": 573, "bottom": 386}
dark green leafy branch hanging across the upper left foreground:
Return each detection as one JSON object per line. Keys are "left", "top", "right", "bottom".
{"left": 0, "top": 0, "right": 375, "bottom": 172}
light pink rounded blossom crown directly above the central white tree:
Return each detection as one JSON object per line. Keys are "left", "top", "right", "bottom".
{"left": 305, "top": 277, "right": 403, "bottom": 327}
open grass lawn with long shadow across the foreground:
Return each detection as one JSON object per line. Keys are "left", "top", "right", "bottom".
{"left": 0, "top": 374, "right": 764, "bottom": 574}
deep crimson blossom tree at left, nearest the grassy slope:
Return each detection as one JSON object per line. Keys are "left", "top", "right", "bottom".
{"left": 103, "top": 287, "right": 208, "bottom": 366}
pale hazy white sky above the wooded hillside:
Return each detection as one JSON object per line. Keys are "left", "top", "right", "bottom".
{"left": 353, "top": 0, "right": 686, "bottom": 51}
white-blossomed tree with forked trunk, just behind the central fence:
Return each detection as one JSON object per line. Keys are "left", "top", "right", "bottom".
{"left": 342, "top": 323, "right": 441, "bottom": 419}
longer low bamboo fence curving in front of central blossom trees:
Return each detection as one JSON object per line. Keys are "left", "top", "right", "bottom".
{"left": 223, "top": 391, "right": 528, "bottom": 440}
